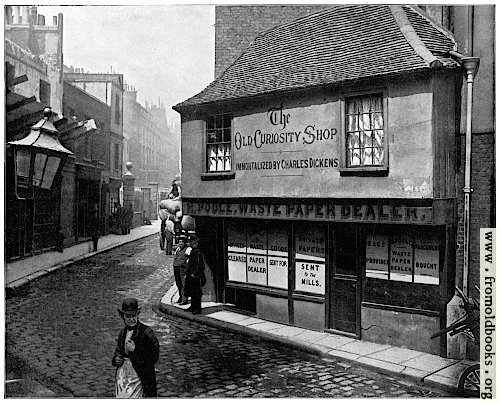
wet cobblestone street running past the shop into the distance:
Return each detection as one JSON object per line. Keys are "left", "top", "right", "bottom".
{"left": 6, "top": 237, "right": 450, "bottom": 398}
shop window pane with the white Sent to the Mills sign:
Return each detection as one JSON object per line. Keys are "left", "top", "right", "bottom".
{"left": 295, "top": 224, "right": 326, "bottom": 294}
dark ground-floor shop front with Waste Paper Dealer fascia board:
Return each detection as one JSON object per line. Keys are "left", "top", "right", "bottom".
{"left": 183, "top": 200, "right": 453, "bottom": 354}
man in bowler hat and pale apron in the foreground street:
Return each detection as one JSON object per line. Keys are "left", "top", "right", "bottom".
{"left": 112, "top": 298, "right": 160, "bottom": 398}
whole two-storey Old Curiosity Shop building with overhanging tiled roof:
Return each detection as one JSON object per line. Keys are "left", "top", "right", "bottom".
{"left": 174, "top": 5, "right": 492, "bottom": 356}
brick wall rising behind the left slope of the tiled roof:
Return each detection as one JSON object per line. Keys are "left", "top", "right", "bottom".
{"left": 215, "top": 4, "right": 331, "bottom": 77}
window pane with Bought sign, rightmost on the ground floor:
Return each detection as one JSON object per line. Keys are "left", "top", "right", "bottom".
{"left": 414, "top": 236, "right": 439, "bottom": 285}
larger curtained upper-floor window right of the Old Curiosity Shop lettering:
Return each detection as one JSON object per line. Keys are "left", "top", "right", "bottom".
{"left": 341, "top": 93, "right": 387, "bottom": 173}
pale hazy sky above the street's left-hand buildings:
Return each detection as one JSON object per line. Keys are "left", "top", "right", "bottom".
{"left": 37, "top": 3, "right": 215, "bottom": 127}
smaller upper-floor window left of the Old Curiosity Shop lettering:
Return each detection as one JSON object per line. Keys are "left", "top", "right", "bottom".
{"left": 206, "top": 114, "right": 232, "bottom": 172}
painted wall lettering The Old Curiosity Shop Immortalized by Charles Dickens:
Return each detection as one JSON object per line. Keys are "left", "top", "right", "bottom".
{"left": 233, "top": 103, "right": 340, "bottom": 176}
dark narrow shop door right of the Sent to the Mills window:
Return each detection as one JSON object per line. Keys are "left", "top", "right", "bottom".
{"left": 330, "top": 227, "right": 361, "bottom": 337}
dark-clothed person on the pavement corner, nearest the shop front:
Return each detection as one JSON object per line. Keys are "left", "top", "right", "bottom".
{"left": 185, "top": 234, "right": 207, "bottom": 315}
